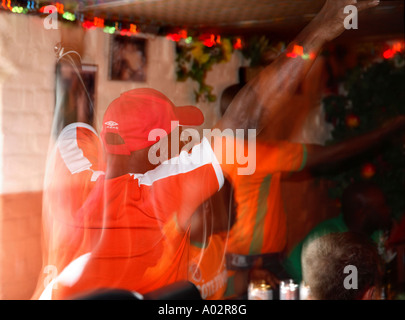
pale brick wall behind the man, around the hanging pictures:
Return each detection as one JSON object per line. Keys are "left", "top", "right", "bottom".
{"left": 0, "top": 13, "right": 243, "bottom": 194}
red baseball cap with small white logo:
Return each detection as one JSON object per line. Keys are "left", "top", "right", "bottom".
{"left": 101, "top": 88, "right": 204, "bottom": 155}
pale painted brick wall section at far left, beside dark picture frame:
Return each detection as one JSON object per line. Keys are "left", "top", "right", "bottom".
{"left": 0, "top": 13, "right": 60, "bottom": 193}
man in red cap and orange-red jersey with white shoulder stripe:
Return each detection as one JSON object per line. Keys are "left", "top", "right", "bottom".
{"left": 47, "top": 88, "right": 223, "bottom": 298}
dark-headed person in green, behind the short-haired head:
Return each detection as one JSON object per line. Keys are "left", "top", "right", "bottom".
{"left": 284, "top": 181, "right": 392, "bottom": 283}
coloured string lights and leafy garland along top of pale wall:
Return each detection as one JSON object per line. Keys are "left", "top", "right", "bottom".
{"left": 0, "top": 0, "right": 290, "bottom": 102}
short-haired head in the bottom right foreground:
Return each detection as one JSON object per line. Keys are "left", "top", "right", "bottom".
{"left": 302, "top": 232, "right": 382, "bottom": 300}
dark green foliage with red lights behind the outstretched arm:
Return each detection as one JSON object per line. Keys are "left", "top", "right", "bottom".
{"left": 323, "top": 54, "right": 405, "bottom": 219}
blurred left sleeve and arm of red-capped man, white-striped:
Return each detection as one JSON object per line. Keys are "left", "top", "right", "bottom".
{"left": 33, "top": 122, "right": 105, "bottom": 299}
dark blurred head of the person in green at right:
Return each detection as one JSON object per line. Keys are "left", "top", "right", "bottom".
{"left": 342, "top": 181, "right": 391, "bottom": 235}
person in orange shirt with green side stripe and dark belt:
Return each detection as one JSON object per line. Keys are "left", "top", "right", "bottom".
{"left": 220, "top": 83, "right": 287, "bottom": 298}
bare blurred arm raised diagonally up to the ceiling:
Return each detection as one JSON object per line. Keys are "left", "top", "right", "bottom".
{"left": 215, "top": 0, "right": 379, "bottom": 134}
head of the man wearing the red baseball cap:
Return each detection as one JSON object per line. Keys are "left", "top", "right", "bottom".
{"left": 101, "top": 88, "right": 204, "bottom": 174}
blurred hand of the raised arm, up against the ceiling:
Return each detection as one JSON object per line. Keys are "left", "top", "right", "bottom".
{"left": 311, "top": 0, "right": 380, "bottom": 41}
